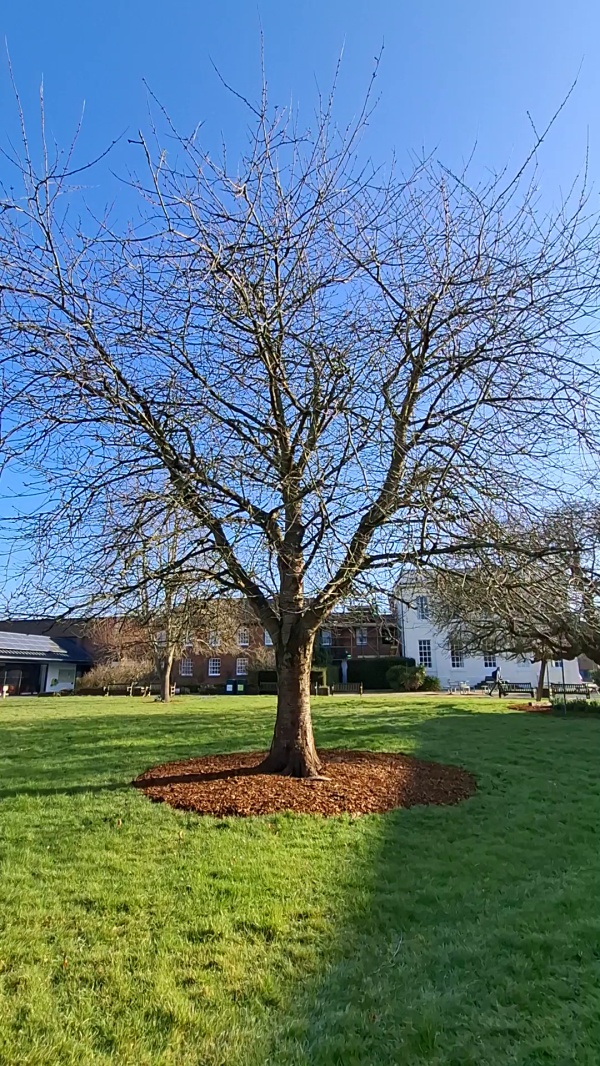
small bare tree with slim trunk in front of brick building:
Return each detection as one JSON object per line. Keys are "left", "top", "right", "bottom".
{"left": 33, "top": 488, "right": 239, "bottom": 702}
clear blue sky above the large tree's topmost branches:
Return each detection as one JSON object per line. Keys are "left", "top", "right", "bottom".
{"left": 0, "top": 0, "right": 600, "bottom": 196}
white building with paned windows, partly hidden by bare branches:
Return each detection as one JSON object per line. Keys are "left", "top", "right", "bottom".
{"left": 398, "top": 585, "right": 581, "bottom": 689}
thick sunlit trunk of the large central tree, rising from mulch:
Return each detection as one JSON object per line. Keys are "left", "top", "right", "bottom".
{"left": 263, "top": 634, "right": 322, "bottom": 777}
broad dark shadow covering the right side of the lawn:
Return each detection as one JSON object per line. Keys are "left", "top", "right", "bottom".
{"left": 254, "top": 712, "right": 600, "bottom": 1066}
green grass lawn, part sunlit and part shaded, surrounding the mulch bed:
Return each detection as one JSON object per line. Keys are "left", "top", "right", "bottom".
{"left": 0, "top": 695, "right": 600, "bottom": 1066}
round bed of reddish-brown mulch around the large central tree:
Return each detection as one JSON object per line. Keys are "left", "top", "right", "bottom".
{"left": 132, "top": 748, "right": 476, "bottom": 818}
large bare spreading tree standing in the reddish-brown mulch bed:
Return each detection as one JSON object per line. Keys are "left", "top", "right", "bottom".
{"left": 0, "top": 77, "right": 600, "bottom": 775}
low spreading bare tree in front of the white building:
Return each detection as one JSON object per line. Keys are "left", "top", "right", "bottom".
{"left": 428, "top": 506, "right": 600, "bottom": 698}
